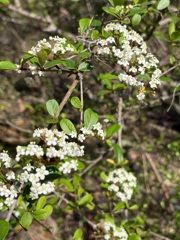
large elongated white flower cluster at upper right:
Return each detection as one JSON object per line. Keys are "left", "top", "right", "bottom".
{"left": 97, "top": 23, "right": 161, "bottom": 101}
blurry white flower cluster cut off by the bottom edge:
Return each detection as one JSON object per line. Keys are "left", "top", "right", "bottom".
{"left": 103, "top": 221, "right": 128, "bottom": 240}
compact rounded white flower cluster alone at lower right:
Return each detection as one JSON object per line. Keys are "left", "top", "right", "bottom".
{"left": 106, "top": 168, "right": 136, "bottom": 202}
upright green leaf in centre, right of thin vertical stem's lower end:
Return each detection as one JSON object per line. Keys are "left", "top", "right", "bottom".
{"left": 84, "top": 108, "right": 98, "bottom": 130}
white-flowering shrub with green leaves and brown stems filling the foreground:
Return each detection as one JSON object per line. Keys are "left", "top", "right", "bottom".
{"left": 0, "top": 1, "right": 172, "bottom": 240}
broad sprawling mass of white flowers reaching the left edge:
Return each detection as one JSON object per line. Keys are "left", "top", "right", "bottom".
{"left": 0, "top": 123, "right": 104, "bottom": 209}
